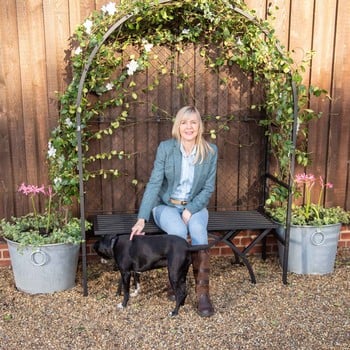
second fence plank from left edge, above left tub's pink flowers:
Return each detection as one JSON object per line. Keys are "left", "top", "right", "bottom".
{"left": 17, "top": 0, "right": 48, "bottom": 194}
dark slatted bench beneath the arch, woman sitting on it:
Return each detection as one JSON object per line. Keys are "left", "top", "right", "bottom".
{"left": 93, "top": 210, "right": 277, "bottom": 283}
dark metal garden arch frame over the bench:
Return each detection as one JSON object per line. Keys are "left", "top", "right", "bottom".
{"left": 76, "top": 0, "right": 298, "bottom": 296}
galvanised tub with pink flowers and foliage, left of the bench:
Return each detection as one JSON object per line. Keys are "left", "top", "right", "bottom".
{"left": 0, "top": 183, "right": 89, "bottom": 294}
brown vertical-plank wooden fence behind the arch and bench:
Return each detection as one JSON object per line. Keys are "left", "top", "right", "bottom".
{"left": 0, "top": 0, "right": 350, "bottom": 218}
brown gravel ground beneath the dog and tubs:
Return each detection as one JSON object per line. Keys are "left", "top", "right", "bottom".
{"left": 0, "top": 250, "right": 350, "bottom": 350}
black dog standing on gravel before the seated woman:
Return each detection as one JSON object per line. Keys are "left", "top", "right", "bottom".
{"left": 94, "top": 234, "right": 208, "bottom": 316}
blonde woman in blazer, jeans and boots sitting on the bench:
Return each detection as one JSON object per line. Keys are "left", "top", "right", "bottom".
{"left": 130, "top": 106, "right": 217, "bottom": 316}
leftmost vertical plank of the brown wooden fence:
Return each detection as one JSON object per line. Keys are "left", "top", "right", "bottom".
{"left": 0, "top": 1, "right": 23, "bottom": 218}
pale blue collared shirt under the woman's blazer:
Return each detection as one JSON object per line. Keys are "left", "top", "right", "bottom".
{"left": 171, "top": 144, "right": 197, "bottom": 200}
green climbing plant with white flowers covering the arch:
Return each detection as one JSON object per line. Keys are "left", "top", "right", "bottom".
{"left": 48, "top": 0, "right": 324, "bottom": 204}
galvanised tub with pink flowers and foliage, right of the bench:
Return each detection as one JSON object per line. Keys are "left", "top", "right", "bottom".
{"left": 266, "top": 173, "right": 350, "bottom": 274}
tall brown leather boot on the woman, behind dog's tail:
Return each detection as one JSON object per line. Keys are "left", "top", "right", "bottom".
{"left": 192, "top": 250, "right": 214, "bottom": 317}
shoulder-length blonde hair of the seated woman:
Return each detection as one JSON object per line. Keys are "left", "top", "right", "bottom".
{"left": 171, "top": 106, "right": 214, "bottom": 163}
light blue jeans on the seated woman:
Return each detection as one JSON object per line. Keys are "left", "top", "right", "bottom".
{"left": 152, "top": 204, "right": 209, "bottom": 245}
